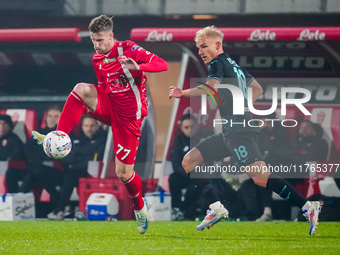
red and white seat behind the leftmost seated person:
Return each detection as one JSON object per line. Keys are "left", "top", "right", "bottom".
{"left": 0, "top": 109, "right": 38, "bottom": 143}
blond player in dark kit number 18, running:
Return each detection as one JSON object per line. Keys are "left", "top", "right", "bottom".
{"left": 169, "top": 26, "right": 321, "bottom": 234}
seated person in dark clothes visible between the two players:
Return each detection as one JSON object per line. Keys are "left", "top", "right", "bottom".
{"left": 169, "top": 113, "right": 212, "bottom": 220}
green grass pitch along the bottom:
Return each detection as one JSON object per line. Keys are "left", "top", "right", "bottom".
{"left": 0, "top": 221, "right": 340, "bottom": 255}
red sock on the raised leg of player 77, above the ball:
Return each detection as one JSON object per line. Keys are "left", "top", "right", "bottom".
{"left": 57, "top": 90, "right": 84, "bottom": 134}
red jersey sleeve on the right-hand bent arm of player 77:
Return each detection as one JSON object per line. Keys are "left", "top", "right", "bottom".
{"left": 129, "top": 41, "right": 168, "bottom": 72}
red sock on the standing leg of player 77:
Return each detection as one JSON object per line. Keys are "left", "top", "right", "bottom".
{"left": 124, "top": 171, "right": 144, "bottom": 210}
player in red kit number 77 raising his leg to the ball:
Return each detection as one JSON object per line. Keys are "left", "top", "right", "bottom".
{"left": 32, "top": 15, "right": 168, "bottom": 234}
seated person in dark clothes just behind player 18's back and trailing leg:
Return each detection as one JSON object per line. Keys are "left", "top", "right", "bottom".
{"left": 239, "top": 112, "right": 291, "bottom": 222}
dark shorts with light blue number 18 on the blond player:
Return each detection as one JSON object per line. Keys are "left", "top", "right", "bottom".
{"left": 196, "top": 132, "right": 263, "bottom": 166}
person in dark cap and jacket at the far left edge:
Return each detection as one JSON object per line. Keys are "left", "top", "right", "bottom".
{"left": 0, "top": 114, "right": 24, "bottom": 160}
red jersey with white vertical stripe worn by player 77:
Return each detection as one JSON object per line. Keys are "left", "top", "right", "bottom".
{"left": 93, "top": 41, "right": 168, "bottom": 120}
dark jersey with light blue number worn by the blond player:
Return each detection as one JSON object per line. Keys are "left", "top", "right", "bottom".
{"left": 207, "top": 53, "right": 258, "bottom": 134}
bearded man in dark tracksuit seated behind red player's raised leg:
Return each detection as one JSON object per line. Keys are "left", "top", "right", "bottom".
{"left": 43, "top": 115, "right": 107, "bottom": 220}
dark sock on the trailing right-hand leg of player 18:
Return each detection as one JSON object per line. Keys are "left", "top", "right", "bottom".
{"left": 266, "top": 174, "right": 307, "bottom": 208}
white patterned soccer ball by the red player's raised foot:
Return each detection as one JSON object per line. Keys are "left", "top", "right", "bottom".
{"left": 43, "top": 131, "right": 72, "bottom": 159}
